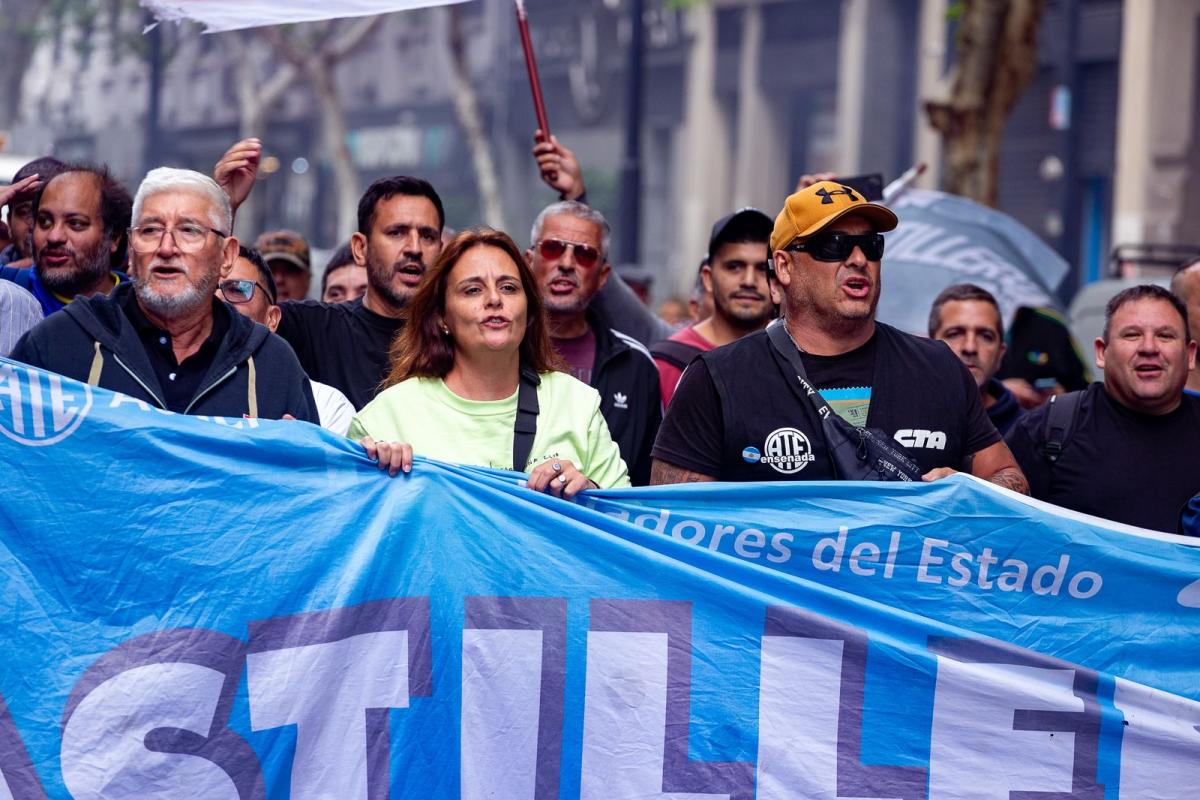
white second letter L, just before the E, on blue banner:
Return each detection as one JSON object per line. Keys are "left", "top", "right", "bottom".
{"left": 757, "top": 636, "right": 842, "bottom": 800}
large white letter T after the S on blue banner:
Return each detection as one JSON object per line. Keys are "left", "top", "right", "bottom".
{"left": 246, "top": 631, "right": 409, "bottom": 800}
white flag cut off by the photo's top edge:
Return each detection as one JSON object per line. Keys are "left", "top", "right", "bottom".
{"left": 142, "top": 0, "right": 463, "bottom": 34}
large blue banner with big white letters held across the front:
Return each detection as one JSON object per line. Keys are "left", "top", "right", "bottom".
{"left": 0, "top": 361, "right": 1200, "bottom": 800}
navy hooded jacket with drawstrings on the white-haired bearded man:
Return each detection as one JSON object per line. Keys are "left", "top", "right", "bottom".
{"left": 10, "top": 283, "right": 317, "bottom": 422}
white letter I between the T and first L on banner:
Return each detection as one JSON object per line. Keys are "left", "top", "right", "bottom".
{"left": 461, "top": 628, "right": 542, "bottom": 800}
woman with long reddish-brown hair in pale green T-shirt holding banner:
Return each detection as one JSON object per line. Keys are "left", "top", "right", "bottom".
{"left": 348, "top": 229, "right": 629, "bottom": 498}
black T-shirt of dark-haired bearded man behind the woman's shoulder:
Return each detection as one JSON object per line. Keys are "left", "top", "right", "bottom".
{"left": 275, "top": 297, "right": 401, "bottom": 409}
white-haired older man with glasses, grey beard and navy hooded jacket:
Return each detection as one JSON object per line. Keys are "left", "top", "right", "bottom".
{"left": 11, "top": 167, "right": 317, "bottom": 422}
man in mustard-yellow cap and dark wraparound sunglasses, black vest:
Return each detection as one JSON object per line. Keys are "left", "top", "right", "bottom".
{"left": 650, "top": 181, "right": 1028, "bottom": 493}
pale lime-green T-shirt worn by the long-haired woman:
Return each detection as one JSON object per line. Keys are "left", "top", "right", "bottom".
{"left": 347, "top": 372, "right": 629, "bottom": 489}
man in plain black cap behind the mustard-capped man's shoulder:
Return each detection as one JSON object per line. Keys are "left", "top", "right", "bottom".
{"left": 650, "top": 209, "right": 773, "bottom": 405}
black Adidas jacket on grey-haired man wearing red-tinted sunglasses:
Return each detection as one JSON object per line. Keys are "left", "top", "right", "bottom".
{"left": 588, "top": 312, "right": 662, "bottom": 486}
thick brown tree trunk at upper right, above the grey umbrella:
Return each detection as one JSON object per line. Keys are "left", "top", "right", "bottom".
{"left": 925, "top": 0, "right": 1044, "bottom": 206}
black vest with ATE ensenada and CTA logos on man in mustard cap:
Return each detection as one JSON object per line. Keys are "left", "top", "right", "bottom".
{"left": 653, "top": 324, "right": 1000, "bottom": 481}
